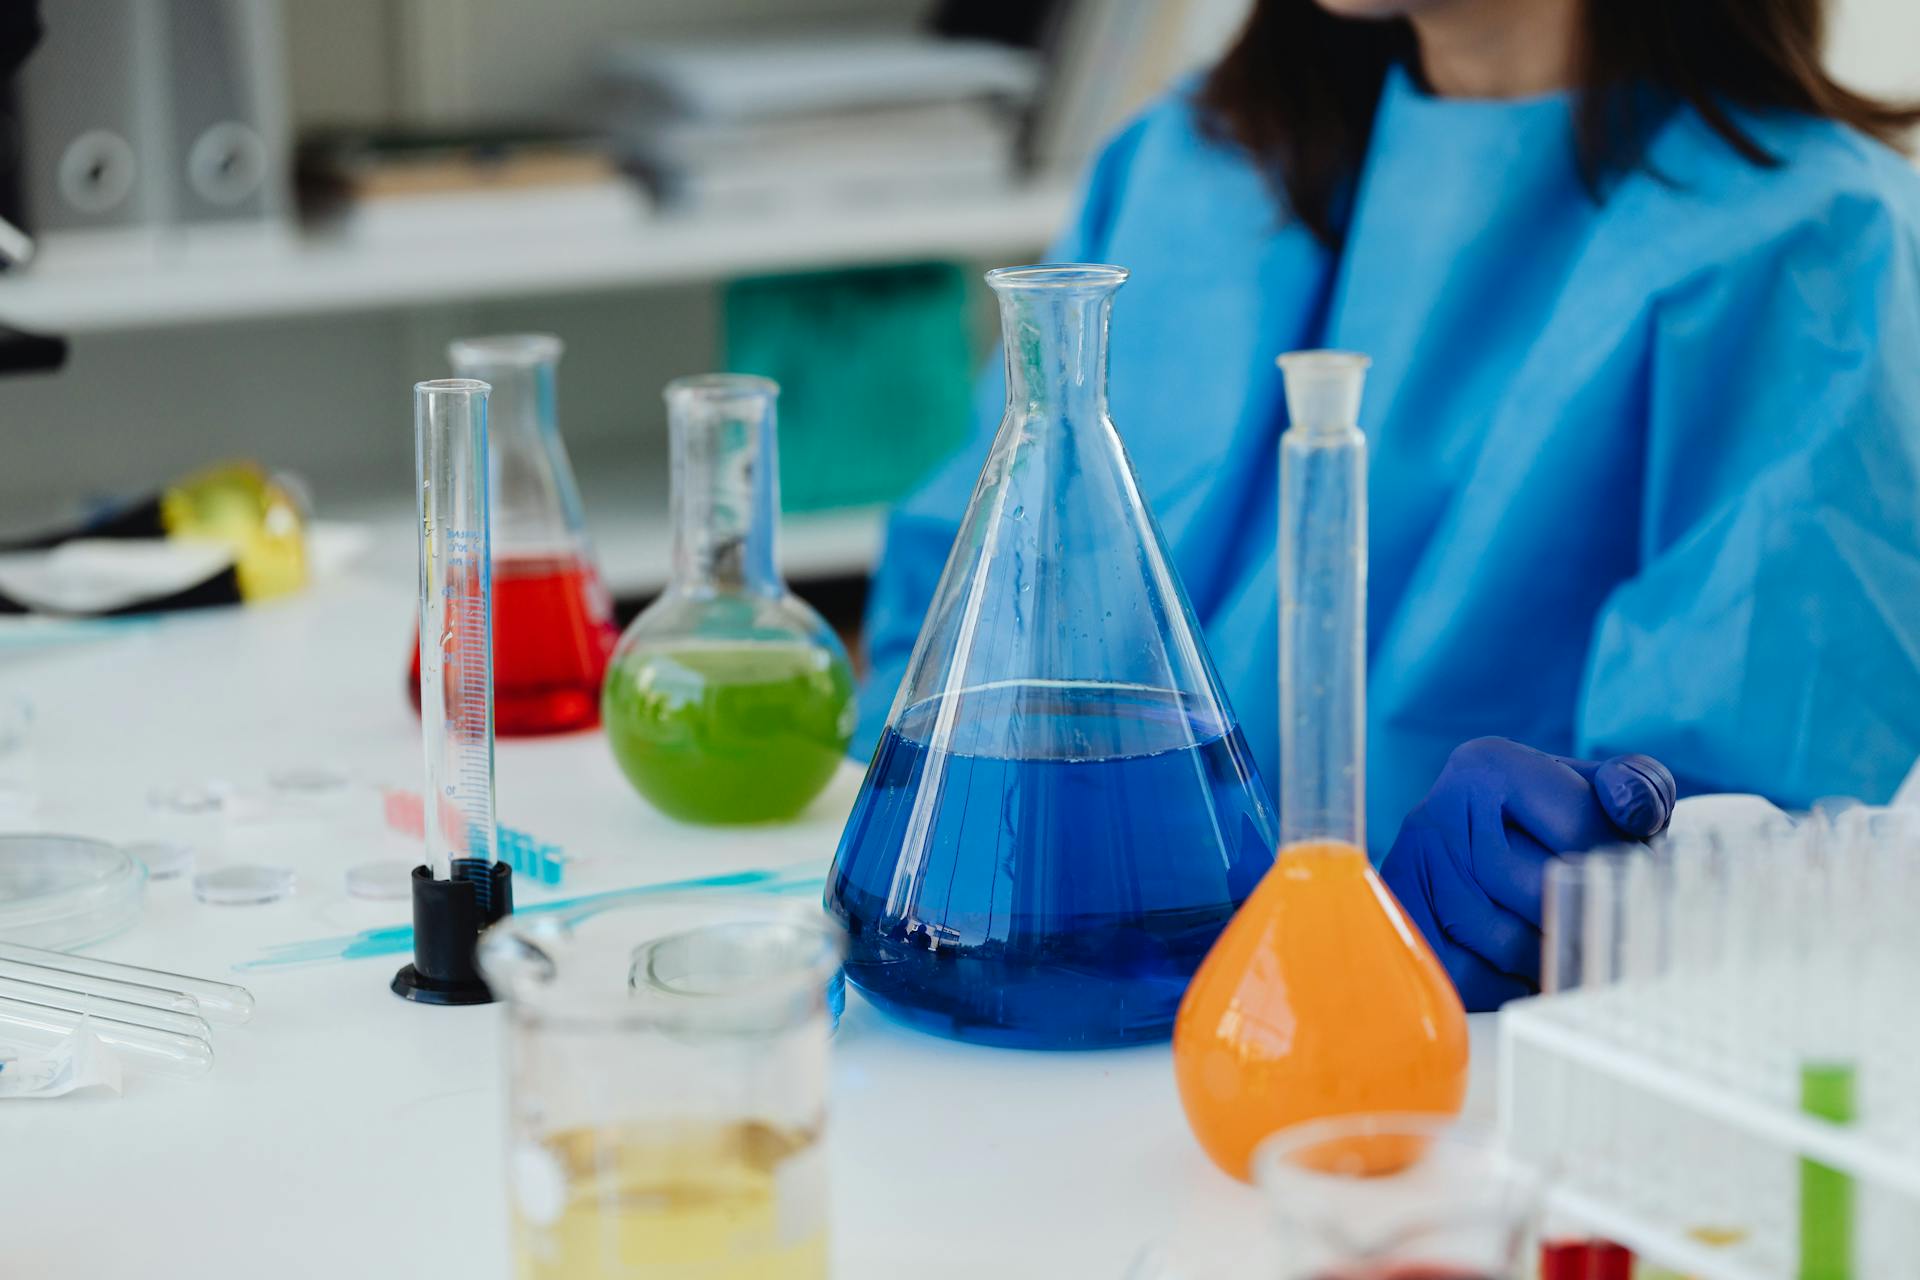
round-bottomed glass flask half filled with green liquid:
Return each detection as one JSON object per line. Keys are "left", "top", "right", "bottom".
{"left": 601, "top": 374, "right": 854, "bottom": 823}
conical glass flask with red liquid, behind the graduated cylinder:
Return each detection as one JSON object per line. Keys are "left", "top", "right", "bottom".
{"left": 407, "top": 334, "right": 618, "bottom": 737}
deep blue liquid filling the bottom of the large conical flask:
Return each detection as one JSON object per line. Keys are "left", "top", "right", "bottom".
{"left": 826, "top": 681, "right": 1275, "bottom": 1048}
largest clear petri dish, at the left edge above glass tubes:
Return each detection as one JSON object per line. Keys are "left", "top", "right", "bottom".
{"left": 0, "top": 833, "right": 146, "bottom": 950}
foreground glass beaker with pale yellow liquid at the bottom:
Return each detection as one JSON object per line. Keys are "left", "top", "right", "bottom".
{"left": 480, "top": 898, "right": 843, "bottom": 1280}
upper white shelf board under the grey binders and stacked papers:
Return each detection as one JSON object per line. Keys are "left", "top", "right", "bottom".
{"left": 0, "top": 184, "right": 1071, "bottom": 334}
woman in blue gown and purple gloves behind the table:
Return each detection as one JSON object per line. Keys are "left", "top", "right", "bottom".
{"left": 854, "top": 0, "right": 1920, "bottom": 1006}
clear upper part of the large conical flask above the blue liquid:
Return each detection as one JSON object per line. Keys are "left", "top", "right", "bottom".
{"left": 893, "top": 267, "right": 1235, "bottom": 760}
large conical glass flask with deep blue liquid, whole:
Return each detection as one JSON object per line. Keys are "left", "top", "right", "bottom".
{"left": 826, "top": 265, "right": 1277, "bottom": 1048}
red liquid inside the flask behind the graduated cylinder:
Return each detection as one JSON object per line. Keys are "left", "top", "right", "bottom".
{"left": 407, "top": 557, "right": 620, "bottom": 737}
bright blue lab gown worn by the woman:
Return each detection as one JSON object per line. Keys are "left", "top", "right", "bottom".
{"left": 854, "top": 73, "right": 1920, "bottom": 854}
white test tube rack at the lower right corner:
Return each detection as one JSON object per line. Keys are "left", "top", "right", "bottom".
{"left": 1500, "top": 979, "right": 1920, "bottom": 1280}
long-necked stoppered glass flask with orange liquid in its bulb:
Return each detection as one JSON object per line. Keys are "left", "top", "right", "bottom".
{"left": 1173, "top": 351, "right": 1467, "bottom": 1180}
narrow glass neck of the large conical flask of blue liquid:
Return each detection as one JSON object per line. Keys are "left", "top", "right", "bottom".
{"left": 995, "top": 282, "right": 1119, "bottom": 424}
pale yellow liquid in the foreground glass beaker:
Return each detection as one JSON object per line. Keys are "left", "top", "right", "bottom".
{"left": 515, "top": 1123, "right": 828, "bottom": 1280}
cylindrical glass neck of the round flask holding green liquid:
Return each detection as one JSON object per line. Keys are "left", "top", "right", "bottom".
{"left": 666, "top": 376, "right": 785, "bottom": 595}
